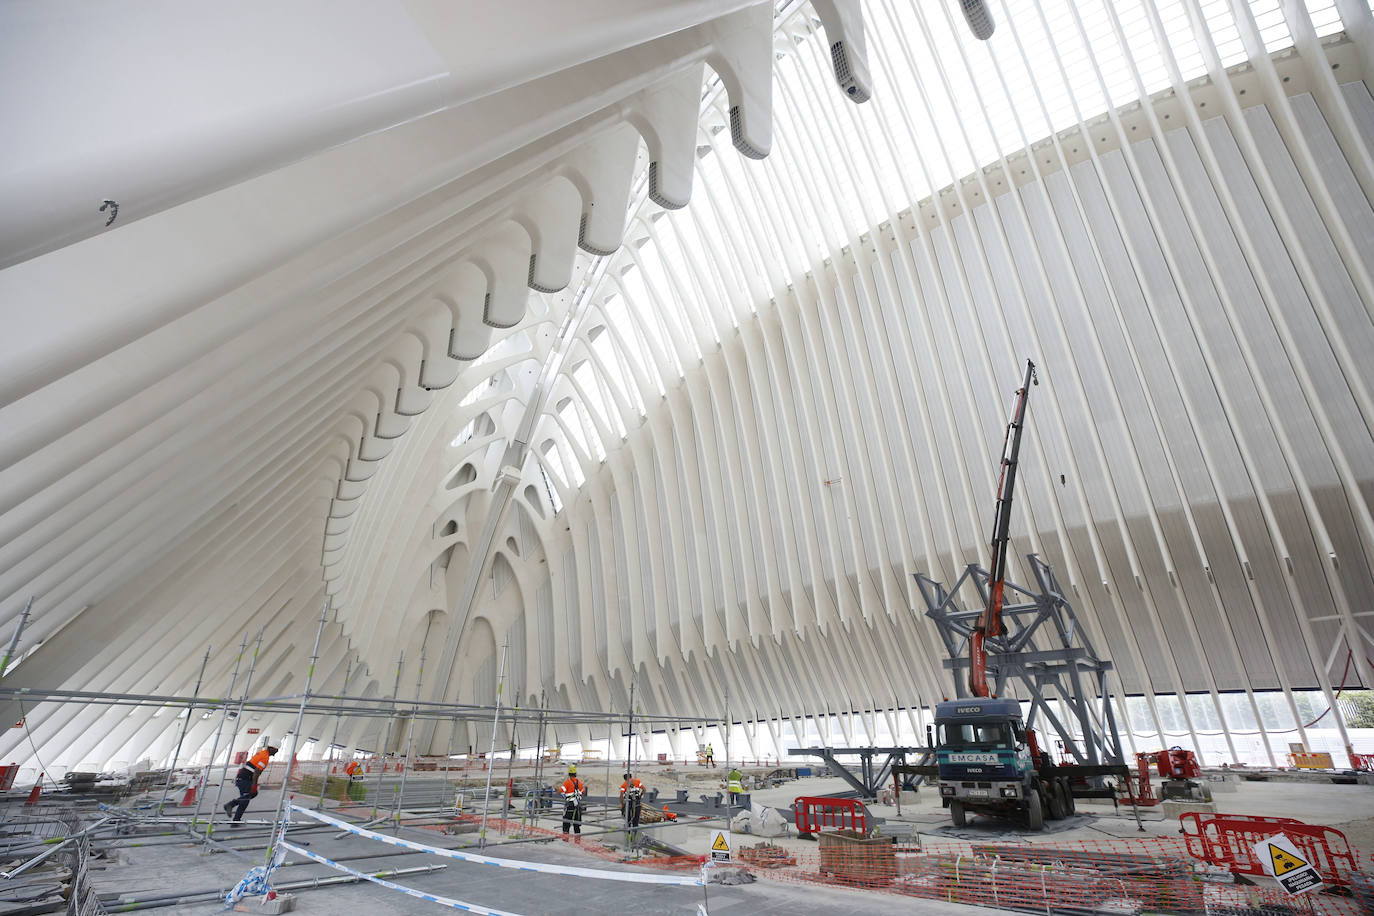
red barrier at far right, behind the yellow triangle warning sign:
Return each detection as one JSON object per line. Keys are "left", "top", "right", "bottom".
{"left": 1179, "top": 812, "right": 1363, "bottom": 886}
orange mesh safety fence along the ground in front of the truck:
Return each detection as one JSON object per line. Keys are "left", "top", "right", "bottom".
{"left": 736, "top": 832, "right": 1367, "bottom": 916}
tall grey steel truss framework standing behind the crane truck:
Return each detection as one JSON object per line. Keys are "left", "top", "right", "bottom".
{"left": 916, "top": 553, "right": 1125, "bottom": 766}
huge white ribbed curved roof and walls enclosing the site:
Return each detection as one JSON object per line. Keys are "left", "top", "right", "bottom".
{"left": 0, "top": 0, "right": 1374, "bottom": 769}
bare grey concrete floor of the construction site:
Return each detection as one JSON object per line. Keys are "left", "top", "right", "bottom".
{"left": 72, "top": 770, "right": 1374, "bottom": 916}
